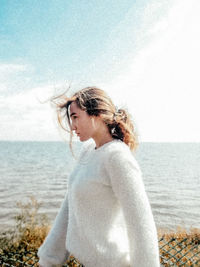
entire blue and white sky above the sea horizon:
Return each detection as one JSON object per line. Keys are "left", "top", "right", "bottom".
{"left": 0, "top": 0, "right": 200, "bottom": 142}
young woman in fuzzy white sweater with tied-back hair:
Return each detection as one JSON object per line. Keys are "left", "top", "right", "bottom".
{"left": 38, "top": 87, "right": 160, "bottom": 267}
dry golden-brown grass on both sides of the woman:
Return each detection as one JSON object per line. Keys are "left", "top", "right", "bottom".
{"left": 0, "top": 197, "right": 200, "bottom": 267}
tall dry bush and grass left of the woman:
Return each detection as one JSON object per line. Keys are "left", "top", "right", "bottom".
{"left": 0, "top": 197, "right": 50, "bottom": 266}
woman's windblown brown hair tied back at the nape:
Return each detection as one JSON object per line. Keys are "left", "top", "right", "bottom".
{"left": 51, "top": 87, "right": 138, "bottom": 150}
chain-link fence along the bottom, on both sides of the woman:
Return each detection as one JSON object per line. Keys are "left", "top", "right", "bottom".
{"left": 0, "top": 235, "right": 200, "bottom": 267}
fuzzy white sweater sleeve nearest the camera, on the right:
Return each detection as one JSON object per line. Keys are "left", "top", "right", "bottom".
{"left": 107, "top": 151, "right": 160, "bottom": 267}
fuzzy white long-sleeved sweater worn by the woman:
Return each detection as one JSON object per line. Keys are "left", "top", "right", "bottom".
{"left": 38, "top": 140, "right": 160, "bottom": 267}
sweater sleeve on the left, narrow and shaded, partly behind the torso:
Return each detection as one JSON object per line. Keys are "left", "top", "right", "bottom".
{"left": 38, "top": 194, "right": 69, "bottom": 267}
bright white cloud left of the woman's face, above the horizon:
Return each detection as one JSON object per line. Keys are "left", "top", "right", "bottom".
{"left": 0, "top": 85, "right": 69, "bottom": 141}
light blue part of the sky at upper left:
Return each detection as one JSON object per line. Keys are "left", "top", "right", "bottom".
{"left": 1, "top": 0, "right": 143, "bottom": 84}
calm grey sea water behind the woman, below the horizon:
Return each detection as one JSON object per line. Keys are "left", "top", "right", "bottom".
{"left": 0, "top": 142, "right": 200, "bottom": 233}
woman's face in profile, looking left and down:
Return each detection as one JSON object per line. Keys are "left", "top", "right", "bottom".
{"left": 70, "top": 102, "right": 97, "bottom": 142}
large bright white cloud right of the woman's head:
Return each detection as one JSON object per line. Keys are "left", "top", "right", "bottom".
{"left": 102, "top": 0, "right": 200, "bottom": 141}
